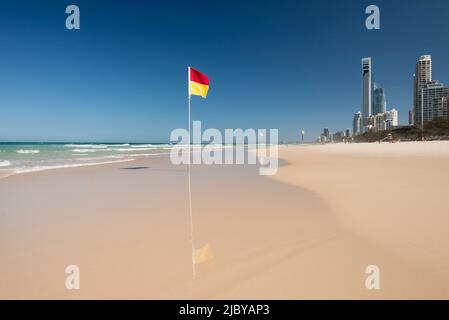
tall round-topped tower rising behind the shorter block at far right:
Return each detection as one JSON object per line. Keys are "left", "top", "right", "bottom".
{"left": 413, "top": 55, "right": 432, "bottom": 127}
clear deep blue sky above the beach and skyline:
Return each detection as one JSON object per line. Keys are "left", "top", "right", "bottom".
{"left": 0, "top": 0, "right": 449, "bottom": 142}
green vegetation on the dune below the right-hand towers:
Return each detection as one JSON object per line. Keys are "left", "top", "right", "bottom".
{"left": 354, "top": 118, "right": 449, "bottom": 142}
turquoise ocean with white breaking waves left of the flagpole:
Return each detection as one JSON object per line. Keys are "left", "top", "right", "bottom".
{"left": 0, "top": 142, "right": 172, "bottom": 178}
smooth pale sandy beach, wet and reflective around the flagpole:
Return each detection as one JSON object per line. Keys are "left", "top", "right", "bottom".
{"left": 0, "top": 142, "right": 449, "bottom": 299}
